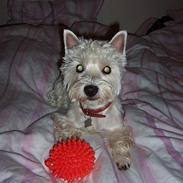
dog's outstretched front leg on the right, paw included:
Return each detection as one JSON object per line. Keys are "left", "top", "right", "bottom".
{"left": 109, "top": 127, "right": 134, "bottom": 170}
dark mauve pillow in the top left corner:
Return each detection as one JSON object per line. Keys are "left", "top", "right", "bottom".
{"left": 8, "top": 0, "right": 54, "bottom": 24}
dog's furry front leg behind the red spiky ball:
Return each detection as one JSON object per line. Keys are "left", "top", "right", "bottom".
{"left": 51, "top": 113, "right": 82, "bottom": 141}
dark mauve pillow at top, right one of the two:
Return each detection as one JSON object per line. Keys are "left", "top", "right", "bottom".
{"left": 54, "top": 0, "right": 103, "bottom": 27}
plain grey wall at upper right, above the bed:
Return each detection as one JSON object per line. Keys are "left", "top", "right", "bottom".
{"left": 98, "top": 0, "right": 183, "bottom": 32}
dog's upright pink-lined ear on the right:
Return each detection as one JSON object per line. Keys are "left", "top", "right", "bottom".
{"left": 109, "top": 31, "right": 127, "bottom": 54}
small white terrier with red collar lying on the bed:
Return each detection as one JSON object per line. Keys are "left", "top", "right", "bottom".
{"left": 48, "top": 30, "right": 134, "bottom": 170}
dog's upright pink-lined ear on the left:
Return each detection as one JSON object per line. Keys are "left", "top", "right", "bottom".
{"left": 63, "top": 29, "right": 79, "bottom": 53}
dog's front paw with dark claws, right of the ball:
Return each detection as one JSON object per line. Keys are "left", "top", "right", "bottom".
{"left": 113, "top": 154, "right": 131, "bottom": 170}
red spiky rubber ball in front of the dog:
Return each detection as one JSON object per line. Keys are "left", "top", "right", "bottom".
{"left": 45, "top": 138, "right": 95, "bottom": 182}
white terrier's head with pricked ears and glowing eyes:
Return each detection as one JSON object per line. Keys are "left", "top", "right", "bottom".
{"left": 61, "top": 30, "right": 127, "bottom": 106}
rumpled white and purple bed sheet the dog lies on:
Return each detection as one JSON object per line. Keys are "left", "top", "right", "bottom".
{"left": 0, "top": 23, "right": 183, "bottom": 183}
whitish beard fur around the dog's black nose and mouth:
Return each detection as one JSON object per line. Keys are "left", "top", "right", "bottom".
{"left": 68, "top": 81, "right": 116, "bottom": 108}
